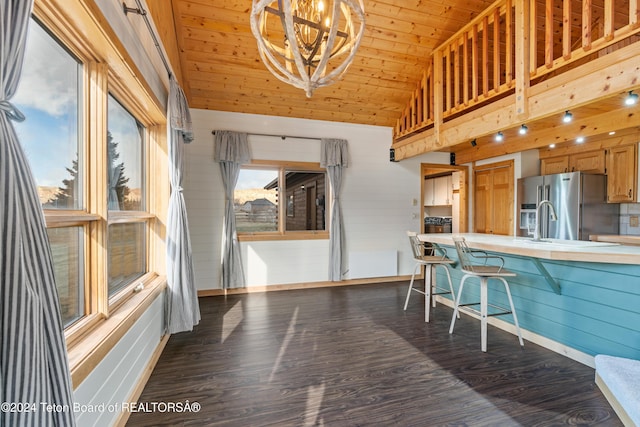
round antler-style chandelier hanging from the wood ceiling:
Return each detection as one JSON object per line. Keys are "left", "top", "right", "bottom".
{"left": 251, "top": 0, "right": 364, "bottom": 98}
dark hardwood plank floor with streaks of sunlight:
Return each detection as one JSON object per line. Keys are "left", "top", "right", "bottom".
{"left": 127, "top": 282, "right": 622, "bottom": 427}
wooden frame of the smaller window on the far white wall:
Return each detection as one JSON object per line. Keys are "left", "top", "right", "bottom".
{"left": 237, "top": 159, "right": 332, "bottom": 242}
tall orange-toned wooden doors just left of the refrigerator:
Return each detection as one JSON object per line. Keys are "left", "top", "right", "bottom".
{"left": 473, "top": 161, "right": 514, "bottom": 235}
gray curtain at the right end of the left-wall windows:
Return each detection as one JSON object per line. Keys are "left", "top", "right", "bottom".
{"left": 167, "top": 76, "right": 200, "bottom": 334}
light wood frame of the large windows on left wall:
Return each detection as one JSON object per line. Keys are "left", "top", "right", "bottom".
{"left": 32, "top": 0, "right": 170, "bottom": 362}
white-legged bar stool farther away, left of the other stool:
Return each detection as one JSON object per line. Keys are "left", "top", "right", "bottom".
{"left": 404, "top": 231, "right": 459, "bottom": 322}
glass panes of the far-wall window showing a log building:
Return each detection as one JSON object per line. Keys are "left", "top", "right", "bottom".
{"left": 234, "top": 163, "right": 327, "bottom": 237}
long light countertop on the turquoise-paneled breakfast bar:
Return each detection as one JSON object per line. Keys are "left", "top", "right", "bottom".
{"left": 418, "top": 233, "right": 640, "bottom": 264}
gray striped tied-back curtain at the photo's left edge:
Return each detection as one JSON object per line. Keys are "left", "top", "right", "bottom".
{"left": 0, "top": 0, "right": 75, "bottom": 426}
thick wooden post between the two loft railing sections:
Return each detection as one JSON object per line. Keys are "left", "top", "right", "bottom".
{"left": 515, "top": 1, "right": 535, "bottom": 120}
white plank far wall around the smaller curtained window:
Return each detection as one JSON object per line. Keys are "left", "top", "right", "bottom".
{"left": 184, "top": 109, "right": 448, "bottom": 290}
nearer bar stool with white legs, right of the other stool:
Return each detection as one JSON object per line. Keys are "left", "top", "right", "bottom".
{"left": 449, "top": 236, "right": 524, "bottom": 352}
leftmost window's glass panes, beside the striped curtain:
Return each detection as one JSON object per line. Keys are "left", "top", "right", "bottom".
{"left": 14, "top": 21, "right": 87, "bottom": 325}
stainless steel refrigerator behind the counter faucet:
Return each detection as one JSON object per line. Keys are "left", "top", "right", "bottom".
{"left": 517, "top": 172, "right": 620, "bottom": 240}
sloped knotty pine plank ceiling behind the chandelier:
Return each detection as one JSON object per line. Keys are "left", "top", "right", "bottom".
{"left": 147, "top": 0, "right": 493, "bottom": 126}
